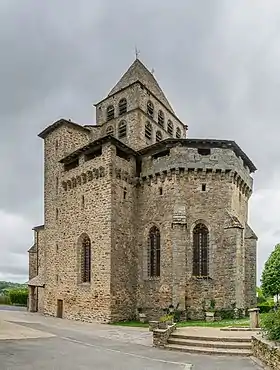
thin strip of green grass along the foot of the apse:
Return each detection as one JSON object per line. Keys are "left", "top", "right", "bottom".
{"left": 111, "top": 314, "right": 266, "bottom": 328}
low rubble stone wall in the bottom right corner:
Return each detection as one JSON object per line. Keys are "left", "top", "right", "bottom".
{"left": 252, "top": 335, "right": 280, "bottom": 370}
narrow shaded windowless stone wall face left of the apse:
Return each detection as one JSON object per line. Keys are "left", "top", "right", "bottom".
{"left": 111, "top": 150, "right": 137, "bottom": 321}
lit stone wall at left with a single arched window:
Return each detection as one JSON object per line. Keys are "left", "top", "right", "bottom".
{"left": 44, "top": 123, "right": 111, "bottom": 321}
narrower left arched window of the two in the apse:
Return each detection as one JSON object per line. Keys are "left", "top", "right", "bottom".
{"left": 148, "top": 226, "right": 160, "bottom": 277}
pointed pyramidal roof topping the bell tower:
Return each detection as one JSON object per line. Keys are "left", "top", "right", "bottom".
{"left": 108, "top": 59, "right": 174, "bottom": 113}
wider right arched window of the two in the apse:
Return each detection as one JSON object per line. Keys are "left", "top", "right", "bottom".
{"left": 193, "top": 223, "right": 209, "bottom": 277}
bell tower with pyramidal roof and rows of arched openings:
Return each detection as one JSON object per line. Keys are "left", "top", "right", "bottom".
{"left": 95, "top": 56, "right": 187, "bottom": 150}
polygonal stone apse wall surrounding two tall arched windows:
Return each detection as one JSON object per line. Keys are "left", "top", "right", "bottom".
{"left": 137, "top": 146, "right": 256, "bottom": 319}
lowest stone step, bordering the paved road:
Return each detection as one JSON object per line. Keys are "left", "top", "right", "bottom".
{"left": 164, "top": 344, "right": 252, "bottom": 356}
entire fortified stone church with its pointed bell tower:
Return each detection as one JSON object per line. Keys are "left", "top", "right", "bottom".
{"left": 28, "top": 58, "right": 257, "bottom": 322}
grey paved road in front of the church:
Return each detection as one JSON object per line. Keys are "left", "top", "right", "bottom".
{"left": 0, "top": 312, "right": 259, "bottom": 370}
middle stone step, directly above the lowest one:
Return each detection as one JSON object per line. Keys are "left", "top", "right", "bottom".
{"left": 168, "top": 337, "right": 252, "bottom": 351}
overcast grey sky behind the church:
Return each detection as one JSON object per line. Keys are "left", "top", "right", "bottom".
{"left": 0, "top": 0, "right": 280, "bottom": 282}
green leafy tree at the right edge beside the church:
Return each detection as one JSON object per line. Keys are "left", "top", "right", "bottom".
{"left": 261, "top": 244, "right": 280, "bottom": 300}
